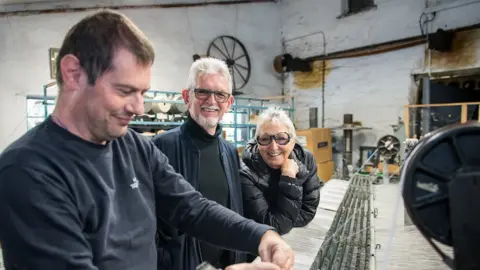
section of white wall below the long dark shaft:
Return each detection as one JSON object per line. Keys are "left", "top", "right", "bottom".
{"left": 295, "top": 46, "right": 423, "bottom": 142}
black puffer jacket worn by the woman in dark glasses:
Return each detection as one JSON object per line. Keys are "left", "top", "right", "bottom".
{"left": 240, "top": 141, "right": 323, "bottom": 234}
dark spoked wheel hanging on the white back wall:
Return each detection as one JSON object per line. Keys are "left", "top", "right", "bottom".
{"left": 207, "top": 36, "right": 251, "bottom": 95}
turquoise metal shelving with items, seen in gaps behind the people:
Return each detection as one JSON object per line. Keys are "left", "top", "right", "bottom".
{"left": 27, "top": 83, "right": 294, "bottom": 146}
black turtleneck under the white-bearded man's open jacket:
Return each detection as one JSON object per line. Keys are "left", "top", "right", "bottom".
{"left": 186, "top": 117, "right": 230, "bottom": 269}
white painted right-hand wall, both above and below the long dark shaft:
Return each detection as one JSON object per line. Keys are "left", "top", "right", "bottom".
{"left": 281, "top": 0, "right": 480, "bottom": 169}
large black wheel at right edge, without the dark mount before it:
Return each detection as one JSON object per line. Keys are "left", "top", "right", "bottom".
{"left": 401, "top": 124, "right": 480, "bottom": 246}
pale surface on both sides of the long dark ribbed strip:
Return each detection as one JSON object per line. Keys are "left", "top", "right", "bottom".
{"left": 284, "top": 180, "right": 451, "bottom": 270}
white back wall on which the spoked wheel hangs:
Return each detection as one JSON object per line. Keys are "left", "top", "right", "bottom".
{"left": 0, "top": 1, "right": 282, "bottom": 151}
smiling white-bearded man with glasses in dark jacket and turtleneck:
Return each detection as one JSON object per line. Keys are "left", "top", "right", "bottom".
{"left": 153, "top": 58, "right": 251, "bottom": 270}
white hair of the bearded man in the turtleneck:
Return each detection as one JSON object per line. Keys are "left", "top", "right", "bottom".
{"left": 187, "top": 57, "right": 232, "bottom": 94}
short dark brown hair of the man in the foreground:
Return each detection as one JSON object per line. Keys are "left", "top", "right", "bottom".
{"left": 56, "top": 9, "right": 155, "bottom": 86}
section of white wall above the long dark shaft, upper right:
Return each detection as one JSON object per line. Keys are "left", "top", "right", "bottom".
{"left": 281, "top": 0, "right": 480, "bottom": 57}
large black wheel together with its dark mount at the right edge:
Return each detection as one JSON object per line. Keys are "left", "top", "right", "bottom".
{"left": 400, "top": 123, "right": 480, "bottom": 270}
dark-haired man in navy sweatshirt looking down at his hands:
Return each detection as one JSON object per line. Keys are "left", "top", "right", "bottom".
{"left": 0, "top": 10, "right": 293, "bottom": 270}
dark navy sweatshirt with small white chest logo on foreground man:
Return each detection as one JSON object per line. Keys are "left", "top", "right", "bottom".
{"left": 0, "top": 118, "right": 272, "bottom": 270}
